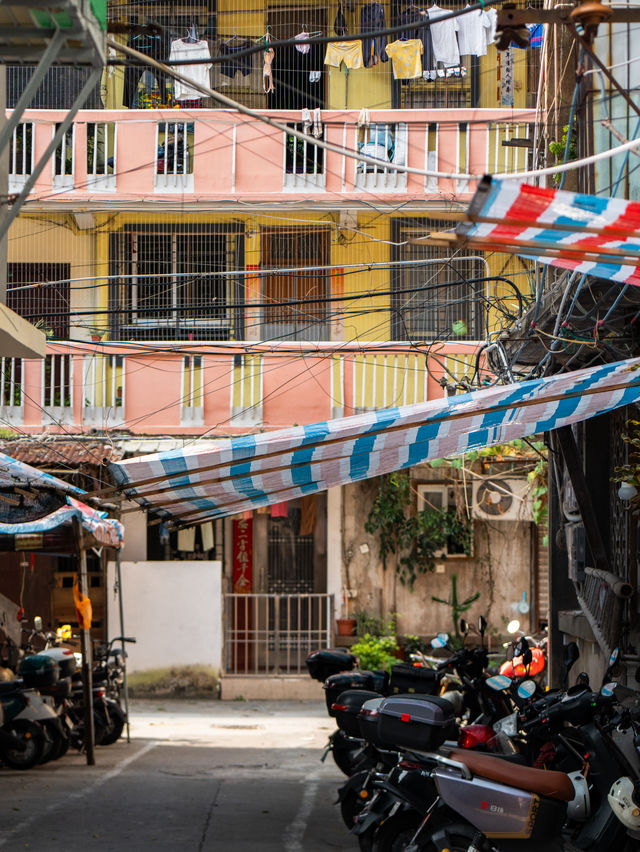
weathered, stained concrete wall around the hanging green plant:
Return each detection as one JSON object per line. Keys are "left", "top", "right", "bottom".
{"left": 340, "top": 467, "right": 532, "bottom": 636}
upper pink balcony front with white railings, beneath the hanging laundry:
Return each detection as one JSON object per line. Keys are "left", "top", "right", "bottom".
{"left": 11, "top": 109, "right": 535, "bottom": 203}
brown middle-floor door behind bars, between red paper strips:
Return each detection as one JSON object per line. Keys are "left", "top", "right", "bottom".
{"left": 262, "top": 226, "right": 331, "bottom": 340}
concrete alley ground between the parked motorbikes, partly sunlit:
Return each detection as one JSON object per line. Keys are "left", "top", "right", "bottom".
{"left": 0, "top": 700, "right": 358, "bottom": 852}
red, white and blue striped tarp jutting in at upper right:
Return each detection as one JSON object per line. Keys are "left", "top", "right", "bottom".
{"left": 456, "top": 177, "right": 640, "bottom": 285}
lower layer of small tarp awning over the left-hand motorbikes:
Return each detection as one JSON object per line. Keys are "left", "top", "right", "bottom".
{"left": 0, "top": 496, "right": 124, "bottom": 553}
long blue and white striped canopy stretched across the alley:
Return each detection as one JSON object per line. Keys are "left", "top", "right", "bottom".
{"left": 110, "top": 359, "right": 640, "bottom": 526}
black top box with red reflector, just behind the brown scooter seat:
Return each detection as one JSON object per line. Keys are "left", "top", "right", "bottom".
{"left": 378, "top": 695, "right": 457, "bottom": 751}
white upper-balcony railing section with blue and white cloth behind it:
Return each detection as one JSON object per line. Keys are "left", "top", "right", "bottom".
{"left": 355, "top": 122, "right": 408, "bottom": 192}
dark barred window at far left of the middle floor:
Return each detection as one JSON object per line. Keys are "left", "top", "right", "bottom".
{"left": 7, "top": 263, "right": 71, "bottom": 340}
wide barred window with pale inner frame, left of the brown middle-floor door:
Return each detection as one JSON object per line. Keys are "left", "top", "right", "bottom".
{"left": 110, "top": 223, "right": 244, "bottom": 340}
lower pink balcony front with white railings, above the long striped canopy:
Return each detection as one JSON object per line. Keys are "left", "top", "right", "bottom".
{"left": 0, "top": 342, "right": 476, "bottom": 436}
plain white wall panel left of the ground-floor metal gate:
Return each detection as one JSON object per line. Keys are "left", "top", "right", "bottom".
{"left": 107, "top": 561, "right": 222, "bottom": 672}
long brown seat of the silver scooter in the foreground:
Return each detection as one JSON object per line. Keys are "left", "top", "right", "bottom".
{"left": 447, "top": 748, "right": 575, "bottom": 802}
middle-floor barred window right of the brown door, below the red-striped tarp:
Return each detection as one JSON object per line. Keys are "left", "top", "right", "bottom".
{"left": 391, "top": 219, "right": 485, "bottom": 340}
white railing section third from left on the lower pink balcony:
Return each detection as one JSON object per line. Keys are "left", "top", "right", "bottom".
{"left": 82, "top": 354, "right": 125, "bottom": 428}
